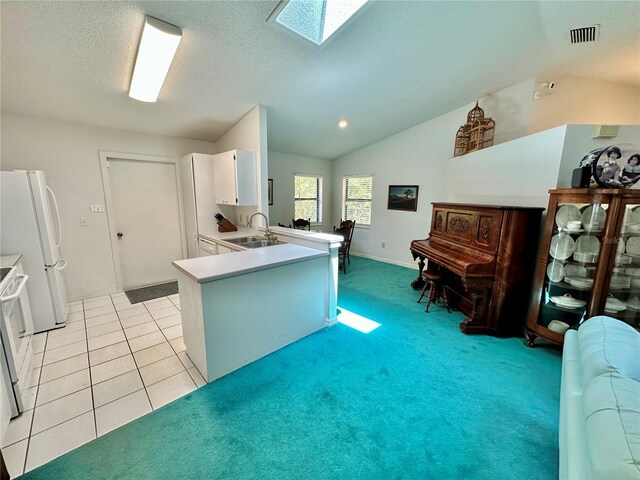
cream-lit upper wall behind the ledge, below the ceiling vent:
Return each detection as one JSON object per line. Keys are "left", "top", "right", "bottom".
{"left": 529, "top": 77, "right": 640, "bottom": 133}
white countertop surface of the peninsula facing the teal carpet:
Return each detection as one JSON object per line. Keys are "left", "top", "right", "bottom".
{"left": 171, "top": 242, "right": 329, "bottom": 283}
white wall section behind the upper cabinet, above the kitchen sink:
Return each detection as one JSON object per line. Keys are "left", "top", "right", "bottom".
{"left": 216, "top": 105, "right": 269, "bottom": 226}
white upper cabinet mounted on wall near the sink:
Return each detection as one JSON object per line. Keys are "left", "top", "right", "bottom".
{"left": 213, "top": 150, "right": 258, "bottom": 206}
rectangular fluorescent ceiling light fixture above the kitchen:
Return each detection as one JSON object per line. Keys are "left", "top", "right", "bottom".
{"left": 129, "top": 17, "right": 182, "bottom": 102}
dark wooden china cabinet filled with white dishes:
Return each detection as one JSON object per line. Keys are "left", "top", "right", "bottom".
{"left": 526, "top": 188, "right": 640, "bottom": 347}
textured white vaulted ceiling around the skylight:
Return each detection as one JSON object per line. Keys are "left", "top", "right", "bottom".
{"left": 0, "top": 1, "right": 640, "bottom": 158}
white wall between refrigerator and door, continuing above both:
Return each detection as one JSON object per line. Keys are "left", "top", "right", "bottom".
{"left": 0, "top": 112, "right": 217, "bottom": 299}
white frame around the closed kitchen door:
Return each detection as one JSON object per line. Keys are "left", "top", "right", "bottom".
{"left": 98, "top": 150, "right": 187, "bottom": 292}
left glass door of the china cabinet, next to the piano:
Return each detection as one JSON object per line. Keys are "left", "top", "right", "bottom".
{"left": 538, "top": 203, "right": 608, "bottom": 335}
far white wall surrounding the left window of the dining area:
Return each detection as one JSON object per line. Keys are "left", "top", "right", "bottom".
{"left": 269, "top": 152, "right": 335, "bottom": 230}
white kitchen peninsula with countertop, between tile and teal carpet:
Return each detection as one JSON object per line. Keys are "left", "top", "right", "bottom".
{"left": 173, "top": 232, "right": 335, "bottom": 382}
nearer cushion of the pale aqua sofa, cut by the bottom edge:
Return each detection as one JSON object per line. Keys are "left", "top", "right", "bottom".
{"left": 582, "top": 373, "right": 640, "bottom": 479}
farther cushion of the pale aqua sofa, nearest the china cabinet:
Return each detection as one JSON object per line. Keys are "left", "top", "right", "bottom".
{"left": 578, "top": 315, "right": 640, "bottom": 385}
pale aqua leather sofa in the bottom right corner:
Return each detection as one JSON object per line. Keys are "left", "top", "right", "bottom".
{"left": 559, "top": 316, "right": 640, "bottom": 480}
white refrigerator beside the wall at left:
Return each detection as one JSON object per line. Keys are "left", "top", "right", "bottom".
{"left": 0, "top": 170, "right": 69, "bottom": 333}
